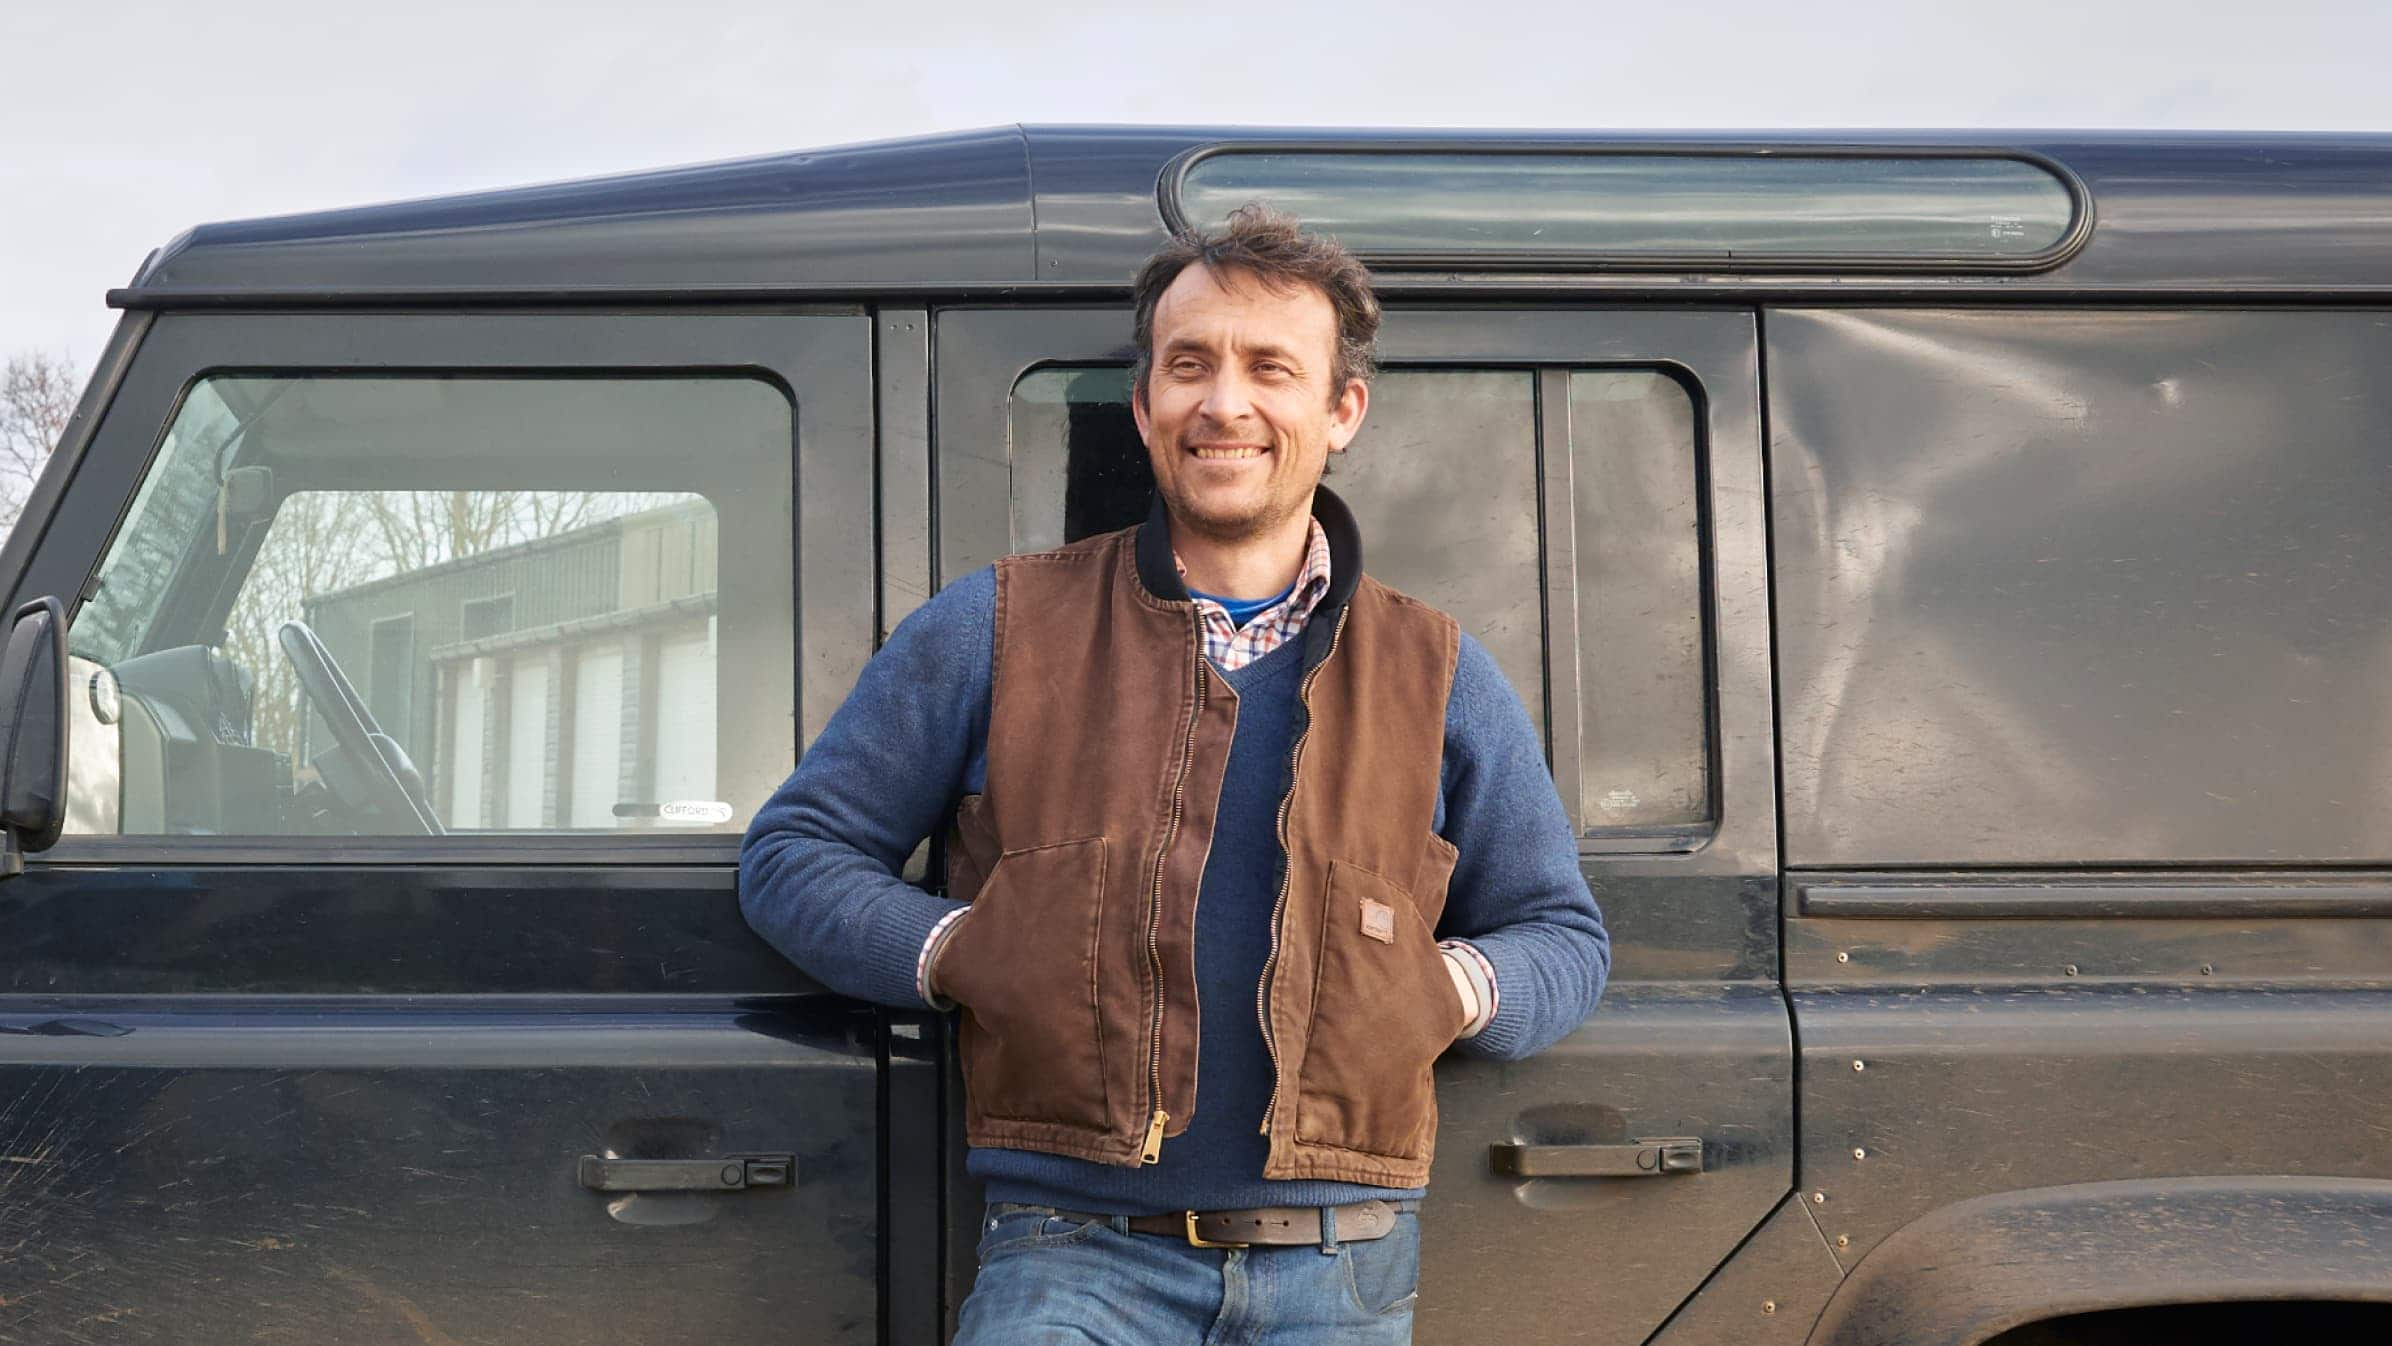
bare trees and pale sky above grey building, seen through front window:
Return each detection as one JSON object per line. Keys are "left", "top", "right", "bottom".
{"left": 225, "top": 490, "right": 658, "bottom": 763}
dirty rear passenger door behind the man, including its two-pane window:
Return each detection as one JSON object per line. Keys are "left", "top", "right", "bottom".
{"left": 933, "top": 308, "right": 1794, "bottom": 1344}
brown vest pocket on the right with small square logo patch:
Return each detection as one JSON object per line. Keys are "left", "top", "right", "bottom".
{"left": 1296, "top": 861, "right": 1464, "bottom": 1160}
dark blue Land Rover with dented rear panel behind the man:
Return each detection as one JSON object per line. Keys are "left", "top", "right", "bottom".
{"left": 0, "top": 127, "right": 2392, "bottom": 1346}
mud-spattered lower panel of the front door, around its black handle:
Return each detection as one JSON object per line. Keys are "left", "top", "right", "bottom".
{"left": 0, "top": 997, "right": 878, "bottom": 1346}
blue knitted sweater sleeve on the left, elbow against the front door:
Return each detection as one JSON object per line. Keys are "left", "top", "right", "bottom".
{"left": 739, "top": 569, "right": 997, "bottom": 1009}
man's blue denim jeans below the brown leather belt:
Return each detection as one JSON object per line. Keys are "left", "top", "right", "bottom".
{"left": 954, "top": 1203, "right": 1421, "bottom": 1346}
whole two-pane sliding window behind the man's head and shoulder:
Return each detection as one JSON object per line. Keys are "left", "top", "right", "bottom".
{"left": 1007, "top": 366, "right": 1713, "bottom": 846}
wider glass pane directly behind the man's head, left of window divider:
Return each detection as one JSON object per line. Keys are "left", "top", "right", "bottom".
{"left": 1012, "top": 366, "right": 1545, "bottom": 732}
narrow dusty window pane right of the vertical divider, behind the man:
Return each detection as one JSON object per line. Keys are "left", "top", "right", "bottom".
{"left": 1569, "top": 371, "right": 1710, "bottom": 830}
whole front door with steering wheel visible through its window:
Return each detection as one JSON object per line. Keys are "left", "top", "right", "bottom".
{"left": 0, "top": 313, "right": 883, "bottom": 1344}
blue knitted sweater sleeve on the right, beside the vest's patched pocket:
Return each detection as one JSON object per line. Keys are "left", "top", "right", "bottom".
{"left": 1438, "top": 634, "right": 1612, "bottom": 1061}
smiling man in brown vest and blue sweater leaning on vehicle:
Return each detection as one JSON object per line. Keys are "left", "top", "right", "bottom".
{"left": 742, "top": 208, "right": 1610, "bottom": 1346}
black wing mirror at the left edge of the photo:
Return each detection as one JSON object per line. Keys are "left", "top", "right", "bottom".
{"left": 0, "top": 598, "right": 67, "bottom": 880}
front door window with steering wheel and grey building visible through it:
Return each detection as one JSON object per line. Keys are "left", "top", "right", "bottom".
{"left": 69, "top": 375, "right": 794, "bottom": 837}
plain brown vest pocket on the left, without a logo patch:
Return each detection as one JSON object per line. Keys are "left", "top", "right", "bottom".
{"left": 938, "top": 837, "right": 1110, "bottom": 1128}
